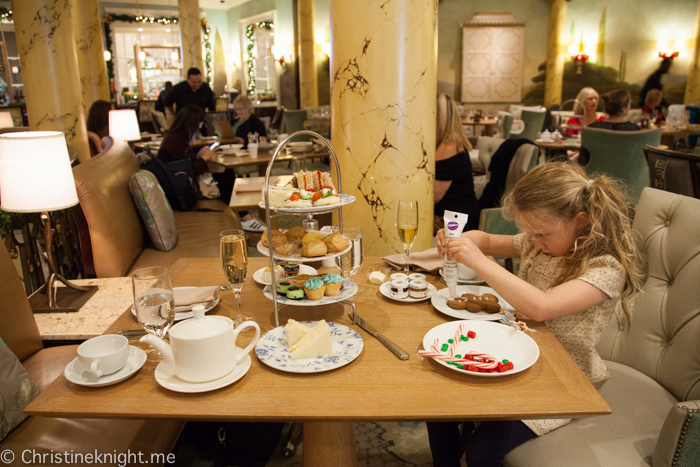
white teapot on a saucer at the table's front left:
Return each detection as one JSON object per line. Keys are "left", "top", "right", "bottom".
{"left": 141, "top": 305, "right": 260, "bottom": 383}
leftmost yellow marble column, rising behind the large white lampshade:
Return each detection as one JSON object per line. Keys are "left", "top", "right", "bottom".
{"left": 12, "top": 0, "right": 90, "bottom": 162}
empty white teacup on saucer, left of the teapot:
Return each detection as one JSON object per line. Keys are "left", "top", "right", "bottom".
{"left": 78, "top": 334, "right": 129, "bottom": 378}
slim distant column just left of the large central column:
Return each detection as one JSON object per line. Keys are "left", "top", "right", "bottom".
{"left": 297, "top": 0, "right": 318, "bottom": 107}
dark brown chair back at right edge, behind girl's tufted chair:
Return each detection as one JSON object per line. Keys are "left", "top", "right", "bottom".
{"left": 644, "top": 144, "right": 700, "bottom": 198}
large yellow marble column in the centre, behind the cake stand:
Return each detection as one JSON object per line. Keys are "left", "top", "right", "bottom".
{"left": 330, "top": 0, "right": 437, "bottom": 256}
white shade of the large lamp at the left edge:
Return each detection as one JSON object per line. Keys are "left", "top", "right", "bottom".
{"left": 0, "top": 131, "right": 78, "bottom": 212}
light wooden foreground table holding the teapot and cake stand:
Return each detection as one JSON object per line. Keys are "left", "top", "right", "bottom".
{"left": 25, "top": 257, "right": 610, "bottom": 466}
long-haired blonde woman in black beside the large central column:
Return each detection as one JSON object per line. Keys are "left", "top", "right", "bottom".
{"left": 434, "top": 93, "right": 481, "bottom": 231}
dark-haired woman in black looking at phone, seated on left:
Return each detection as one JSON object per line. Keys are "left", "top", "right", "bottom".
{"left": 158, "top": 104, "right": 266, "bottom": 232}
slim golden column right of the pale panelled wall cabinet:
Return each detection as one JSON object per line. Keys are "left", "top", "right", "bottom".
{"left": 544, "top": 0, "right": 567, "bottom": 108}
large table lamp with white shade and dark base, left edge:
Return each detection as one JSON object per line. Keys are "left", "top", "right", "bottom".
{"left": 0, "top": 131, "right": 97, "bottom": 313}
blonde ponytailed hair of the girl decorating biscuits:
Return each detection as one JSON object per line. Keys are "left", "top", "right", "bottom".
{"left": 502, "top": 162, "right": 642, "bottom": 323}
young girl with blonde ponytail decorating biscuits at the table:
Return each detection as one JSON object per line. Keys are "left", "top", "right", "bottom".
{"left": 428, "top": 162, "right": 641, "bottom": 467}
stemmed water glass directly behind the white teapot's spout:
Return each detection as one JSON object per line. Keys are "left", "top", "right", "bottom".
{"left": 131, "top": 266, "right": 175, "bottom": 339}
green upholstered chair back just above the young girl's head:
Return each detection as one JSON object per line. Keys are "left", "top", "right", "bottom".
{"left": 581, "top": 128, "right": 661, "bottom": 203}
